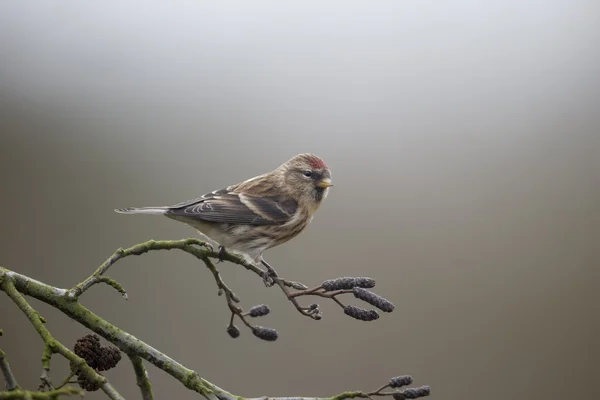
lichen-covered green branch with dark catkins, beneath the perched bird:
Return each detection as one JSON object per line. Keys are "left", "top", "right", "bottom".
{"left": 0, "top": 239, "right": 429, "bottom": 400}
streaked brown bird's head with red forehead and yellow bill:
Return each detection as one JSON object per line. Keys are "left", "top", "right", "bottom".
{"left": 279, "top": 153, "right": 333, "bottom": 211}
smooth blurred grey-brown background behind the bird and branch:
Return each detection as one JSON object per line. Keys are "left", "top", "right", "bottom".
{"left": 0, "top": 1, "right": 600, "bottom": 399}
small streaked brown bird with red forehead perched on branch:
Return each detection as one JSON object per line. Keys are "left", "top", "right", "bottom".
{"left": 115, "top": 153, "right": 333, "bottom": 273}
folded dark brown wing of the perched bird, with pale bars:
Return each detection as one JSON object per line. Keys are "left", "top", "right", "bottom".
{"left": 167, "top": 189, "right": 298, "bottom": 225}
